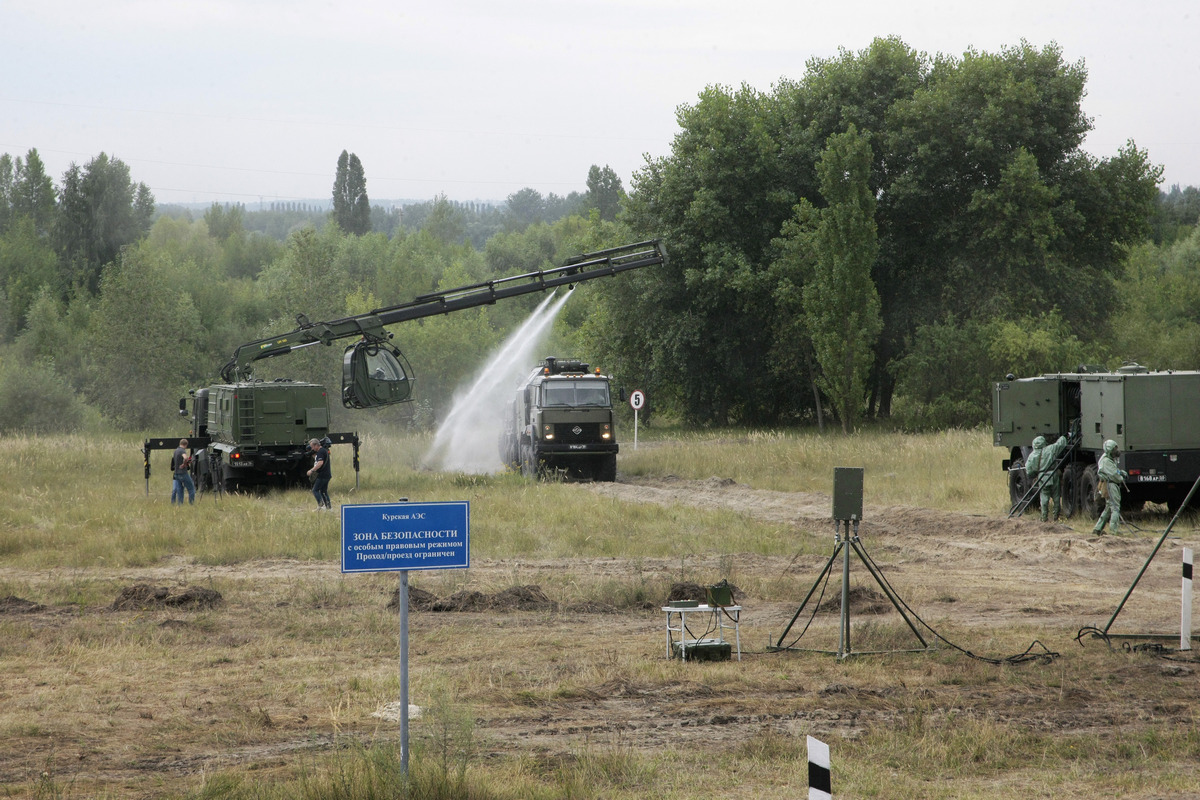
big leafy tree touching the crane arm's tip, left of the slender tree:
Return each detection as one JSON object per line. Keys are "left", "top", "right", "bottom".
{"left": 609, "top": 86, "right": 809, "bottom": 425}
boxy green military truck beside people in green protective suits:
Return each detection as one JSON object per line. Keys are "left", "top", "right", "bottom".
{"left": 992, "top": 363, "right": 1200, "bottom": 517}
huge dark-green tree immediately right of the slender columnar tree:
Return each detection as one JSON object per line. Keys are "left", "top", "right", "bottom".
{"left": 876, "top": 42, "right": 1159, "bottom": 413}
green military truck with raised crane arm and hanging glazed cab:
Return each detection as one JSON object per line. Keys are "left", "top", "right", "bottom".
{"left": 142, "top": 241, "right": 666, "bottom": 493}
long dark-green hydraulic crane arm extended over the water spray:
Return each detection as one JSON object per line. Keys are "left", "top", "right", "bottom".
{"left": 221, "top": 240, "right": 667, "bottom": 383}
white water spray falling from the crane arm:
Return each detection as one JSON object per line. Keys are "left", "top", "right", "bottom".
{"left": 421, "top": 291, "right": 571, "bottom": 475}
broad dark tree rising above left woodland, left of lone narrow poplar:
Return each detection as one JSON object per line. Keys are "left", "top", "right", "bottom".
{"left": 55, "top": 152, "right": 154, "bottom": 294}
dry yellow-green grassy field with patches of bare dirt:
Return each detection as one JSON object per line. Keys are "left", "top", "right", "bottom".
{"left": 0, "top": 429, "right": 1200, "bottom": 800}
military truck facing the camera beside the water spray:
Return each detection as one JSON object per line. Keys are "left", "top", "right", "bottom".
{"left": 500, "top": 357, "right": 619, "bottom": 481}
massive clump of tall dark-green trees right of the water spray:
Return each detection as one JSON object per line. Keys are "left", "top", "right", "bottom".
{"left": 595, "top": 37, "right": 1180, "bottom": 427}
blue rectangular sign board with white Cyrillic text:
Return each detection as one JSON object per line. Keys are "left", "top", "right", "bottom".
{"left": 342, "top": 503, "right": 470, "bottom": 572}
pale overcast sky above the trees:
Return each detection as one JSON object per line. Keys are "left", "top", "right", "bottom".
{"left": 0, "top": 0, "right": 1200, "bottom": 207}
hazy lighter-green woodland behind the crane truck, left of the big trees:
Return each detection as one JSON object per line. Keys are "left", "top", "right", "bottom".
{"left": 0, "top": 143, "right": 623, "bottom": 433}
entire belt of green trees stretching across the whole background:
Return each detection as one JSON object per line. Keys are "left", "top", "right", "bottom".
{"left": 0, "top": 37, "right": 1200, "bottom": 432}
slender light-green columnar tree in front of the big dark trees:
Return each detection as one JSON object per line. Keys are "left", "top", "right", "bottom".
{"left": 804, "top": 124, "right": 882, "bottom": 433}
